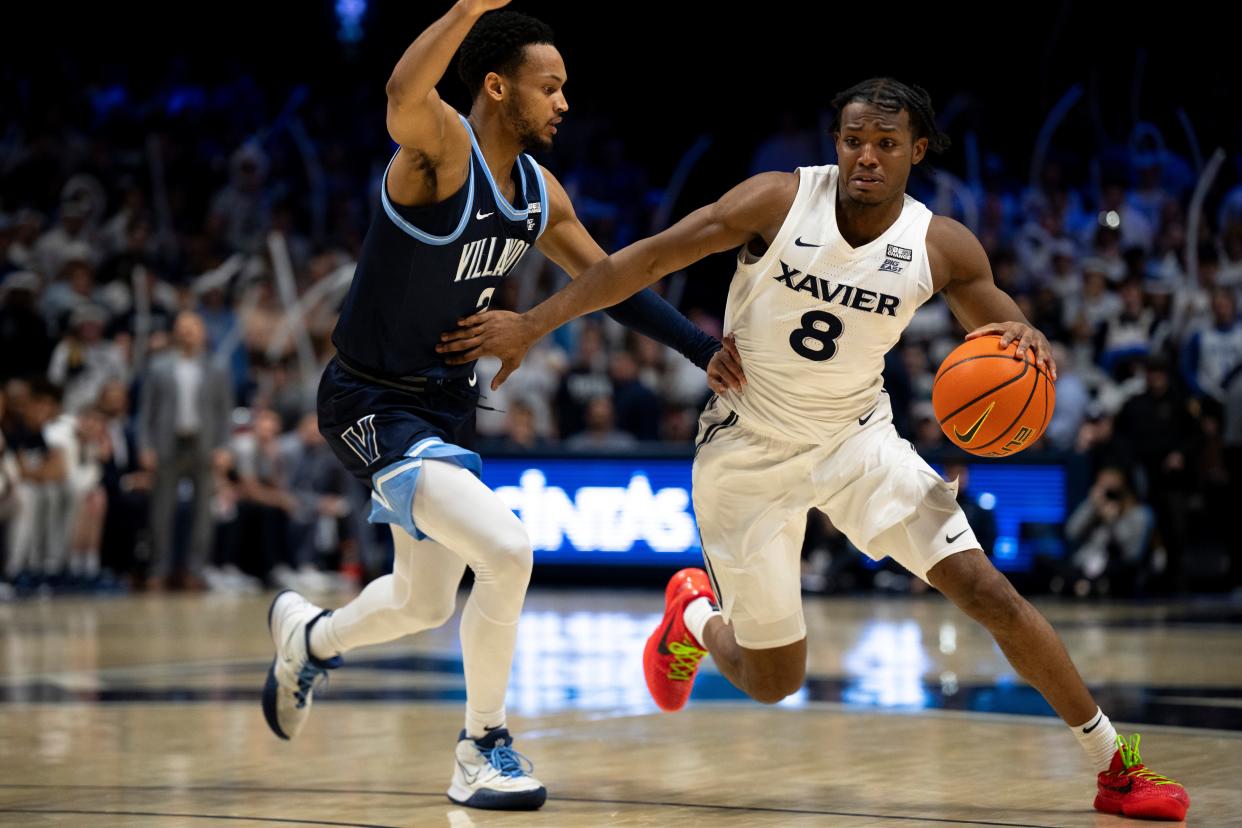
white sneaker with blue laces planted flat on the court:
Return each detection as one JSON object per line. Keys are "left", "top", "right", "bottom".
{"left": 448, "top": 727, "right": 548, "bottom": 811}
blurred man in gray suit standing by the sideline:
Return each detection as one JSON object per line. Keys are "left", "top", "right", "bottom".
{"left": 138, "top": 310, "right": 233, "bottom": 590}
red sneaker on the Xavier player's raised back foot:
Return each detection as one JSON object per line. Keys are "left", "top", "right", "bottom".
{"left": 642, "top": 569, "right": 715, "bottom": 713}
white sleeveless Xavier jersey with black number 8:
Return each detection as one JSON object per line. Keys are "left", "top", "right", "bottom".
{"left": 722, "top": 165, "right": 933, "bottom": 443}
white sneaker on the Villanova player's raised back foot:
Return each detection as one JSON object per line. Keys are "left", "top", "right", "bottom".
{"left": 263, "top": 590, "right": 342, "bottom": 739}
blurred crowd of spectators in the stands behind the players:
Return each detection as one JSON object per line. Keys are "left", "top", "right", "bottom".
{"left": 0, "top": 63, "right": 1242, "bottom": 596}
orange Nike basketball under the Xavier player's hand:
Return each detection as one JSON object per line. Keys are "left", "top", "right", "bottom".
{"left": 932, "top": 334, "right": 1057, "bottom": 457}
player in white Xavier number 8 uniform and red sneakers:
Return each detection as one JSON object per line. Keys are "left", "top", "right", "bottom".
{"left": 440, "top": 78, "right": 1190, "bottom": 819}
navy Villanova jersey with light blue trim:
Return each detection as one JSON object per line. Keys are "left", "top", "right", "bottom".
{"left": 332, "top": 115, "right": 548, "bottom": 379}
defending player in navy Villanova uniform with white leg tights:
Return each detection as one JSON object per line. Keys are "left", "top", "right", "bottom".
{"left": 263, "top": 0, "right": 738, "bottom": 809}
